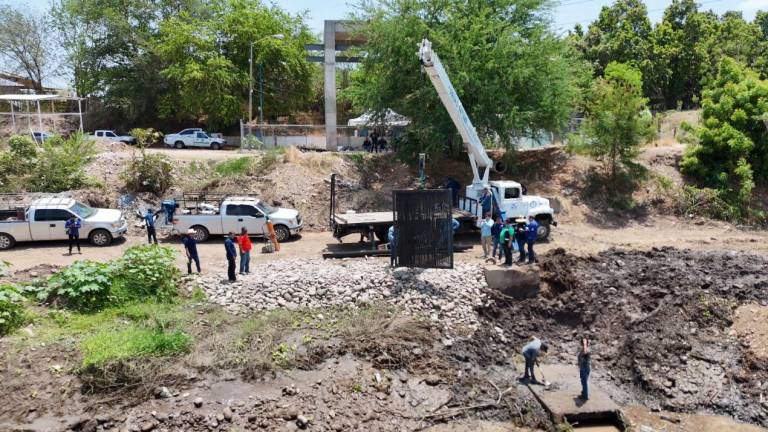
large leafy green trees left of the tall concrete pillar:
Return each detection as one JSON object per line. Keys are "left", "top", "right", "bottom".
{"left": 51, "top": 0, "right": 319, "bottom": 129}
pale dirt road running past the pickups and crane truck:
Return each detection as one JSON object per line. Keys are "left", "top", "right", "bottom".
{"left": 0, "top": 217, "right": 768, "bottom": 272}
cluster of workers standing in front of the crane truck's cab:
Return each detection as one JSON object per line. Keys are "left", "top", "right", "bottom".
{"left": 478, "top": 213, "right": 539, "bottom": 266}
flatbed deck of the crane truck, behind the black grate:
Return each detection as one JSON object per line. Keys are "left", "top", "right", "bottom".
{"left": 328, "top": 174, "right": 480, "bottom": 243}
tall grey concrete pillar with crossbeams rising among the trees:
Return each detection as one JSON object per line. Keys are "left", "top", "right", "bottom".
{"left": 306, "top": 20, "right": 365, "bottom": 150}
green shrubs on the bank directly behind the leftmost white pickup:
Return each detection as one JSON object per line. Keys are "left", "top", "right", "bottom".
{"left": 0, "top": 134, "right": 95, "bottom": 192}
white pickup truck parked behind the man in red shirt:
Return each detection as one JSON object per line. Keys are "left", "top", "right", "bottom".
{"left": 173, "top": 196, "right": 304, "bottom": 242}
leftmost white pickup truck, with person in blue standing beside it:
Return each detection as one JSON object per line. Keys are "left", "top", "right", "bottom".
{"left": 0, "top": 197, "right": 128, "bottom": 250}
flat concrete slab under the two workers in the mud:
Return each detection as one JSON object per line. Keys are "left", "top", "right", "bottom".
{"left": 528, "top": 365, "right": 620, "bottom": 423}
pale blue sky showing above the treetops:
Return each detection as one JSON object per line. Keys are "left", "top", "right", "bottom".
{"left": 6, "top": 0, "right": 768, "bottom": 34}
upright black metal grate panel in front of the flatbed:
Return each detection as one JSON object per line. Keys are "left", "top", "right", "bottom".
{"left": 392, "top": 189, "right": 453, "bottom": 268}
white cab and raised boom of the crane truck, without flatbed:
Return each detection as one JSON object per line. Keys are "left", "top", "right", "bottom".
{"left": 418, "top": 39, "right": 557, "bottom": 240}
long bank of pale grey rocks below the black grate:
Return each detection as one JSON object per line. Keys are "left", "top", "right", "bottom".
{"left": 190, "top": 259, "right": 489, "bottom": 332}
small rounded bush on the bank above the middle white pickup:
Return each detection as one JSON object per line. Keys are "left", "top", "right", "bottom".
{"left": 121, "top": 149, "right": 173, "bottom": 196}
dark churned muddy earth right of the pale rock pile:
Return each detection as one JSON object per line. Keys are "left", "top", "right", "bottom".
{"left": 454, "top": 248, "right": 768, "bottom": 427}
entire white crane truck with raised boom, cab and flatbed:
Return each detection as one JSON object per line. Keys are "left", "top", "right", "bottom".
{"left": 329, "top": 39, "right": 557, "bottom": 241}
